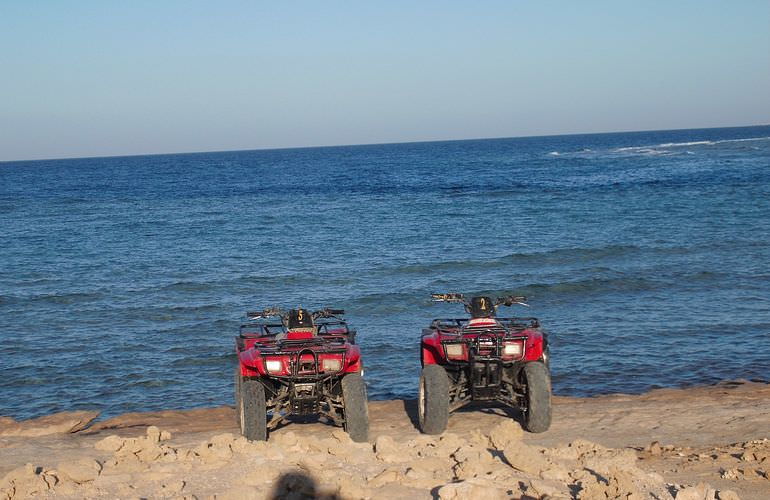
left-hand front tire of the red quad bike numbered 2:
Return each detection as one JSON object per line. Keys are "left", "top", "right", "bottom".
{"left": 417, "top": 365, "right": 449, "bottom": 434}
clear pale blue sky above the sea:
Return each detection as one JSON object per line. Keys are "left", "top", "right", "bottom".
{"left": 0, "top": 0, "right": 770, "bottom": 160}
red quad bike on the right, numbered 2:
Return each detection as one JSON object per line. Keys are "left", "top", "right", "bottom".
{"left": 418, "top": 293, "right": 551, "bottom": 434}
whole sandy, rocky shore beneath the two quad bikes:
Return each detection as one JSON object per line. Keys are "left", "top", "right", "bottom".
{"left": 0, "top": 381, "right": 770, "bottom": 500}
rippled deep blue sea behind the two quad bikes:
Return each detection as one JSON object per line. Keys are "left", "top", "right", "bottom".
{"left": 0, "top": 126, "right": 770, "bottom": 418}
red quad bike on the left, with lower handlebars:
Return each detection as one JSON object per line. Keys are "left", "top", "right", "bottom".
{"left": 235, "top": 309, "right": 369, "bottom": 442}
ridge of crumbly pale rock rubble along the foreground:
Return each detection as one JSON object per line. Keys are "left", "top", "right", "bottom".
{"left": 0, "top": 420, "right": 744, "bottom": 500}
